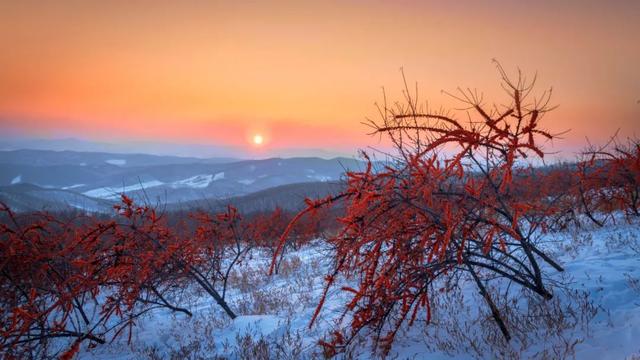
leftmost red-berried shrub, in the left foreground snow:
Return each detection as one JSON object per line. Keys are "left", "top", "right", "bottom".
{"left": 0, "top": 196, "right": 200, "bottom": 358}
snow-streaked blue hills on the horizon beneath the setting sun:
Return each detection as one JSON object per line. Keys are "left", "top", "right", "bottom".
{"left": 0, "top": 150, "right": 364, "bottom": 211}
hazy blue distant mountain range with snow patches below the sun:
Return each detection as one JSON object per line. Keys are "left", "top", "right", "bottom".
{"left": 0, "top": 150, "right": 364, "bottom": 212}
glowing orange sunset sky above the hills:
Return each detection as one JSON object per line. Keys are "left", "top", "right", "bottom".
{"left": 0, "top": 0, "right": 640, "bottom": 155}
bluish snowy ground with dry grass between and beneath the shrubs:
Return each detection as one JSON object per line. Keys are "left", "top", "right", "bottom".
{"left": 80, "top": 224, "right": 640, "bottom": 359}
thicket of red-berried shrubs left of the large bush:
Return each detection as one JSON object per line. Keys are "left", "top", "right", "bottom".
{"left": 0, "top": 195, "right": 317, "bottom": 358}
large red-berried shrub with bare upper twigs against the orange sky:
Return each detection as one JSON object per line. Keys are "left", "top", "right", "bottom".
{"left": 272, "top": 65, "right": 562, "bottom": 354}
